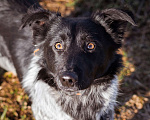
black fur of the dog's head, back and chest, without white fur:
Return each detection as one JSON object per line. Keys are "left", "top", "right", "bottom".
{"left": 0, "top": 0, "right": 135, "bottom": 120}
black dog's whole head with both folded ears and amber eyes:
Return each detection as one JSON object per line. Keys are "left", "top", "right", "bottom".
{"left": 22, "top": 9, "right": 135, "bottom": 91}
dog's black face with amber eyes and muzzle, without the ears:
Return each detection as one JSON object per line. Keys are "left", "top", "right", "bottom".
{"left": 44, "top": 18, "right": 115, "bottom": 90}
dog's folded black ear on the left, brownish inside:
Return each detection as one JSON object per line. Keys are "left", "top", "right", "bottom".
{"left": 21, "top": 9, "right": 61, "bottom": 45}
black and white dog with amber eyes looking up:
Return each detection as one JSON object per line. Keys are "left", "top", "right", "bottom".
{"left": 0, "top": 0, "right": 135, "bottom": 120}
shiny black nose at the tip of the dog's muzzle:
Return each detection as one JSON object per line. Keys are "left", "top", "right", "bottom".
{"left": 60, "top": 72, "right": 78, "bottom": 88}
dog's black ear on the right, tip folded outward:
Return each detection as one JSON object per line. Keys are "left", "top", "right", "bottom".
{"left": 92, "top": 9, "right": 136, "bottom": 44}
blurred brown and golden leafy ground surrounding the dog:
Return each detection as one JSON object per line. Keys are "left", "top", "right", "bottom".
{"left": 0, "top": 0, "right": 150, "bottom": 120}
